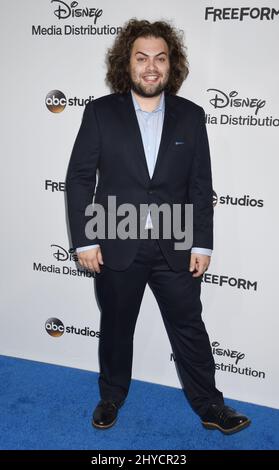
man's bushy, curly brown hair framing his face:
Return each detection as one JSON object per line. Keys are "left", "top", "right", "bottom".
{"left": 106, "top": 18, "right": 189, "bottom": 94}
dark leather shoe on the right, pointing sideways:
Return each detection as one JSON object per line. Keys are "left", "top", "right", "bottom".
{"left": 202, "top": 405, "right": 251, "bottom": 434}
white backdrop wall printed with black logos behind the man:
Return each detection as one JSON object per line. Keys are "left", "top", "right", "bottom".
{"left": 0, "top": 0, "right": 279, "bottom": 408}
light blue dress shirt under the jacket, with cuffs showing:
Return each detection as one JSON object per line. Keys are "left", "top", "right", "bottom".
{"left": 76, "top": 92, "right": 212, "bottom": 256}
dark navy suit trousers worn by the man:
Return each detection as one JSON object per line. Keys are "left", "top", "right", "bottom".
{"left": 96, "top": 239, "right": 223, "bottom": 416}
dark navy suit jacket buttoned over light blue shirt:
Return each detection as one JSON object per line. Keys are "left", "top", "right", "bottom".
{"left": 66, "top": 93, "right": 213, "bottom": 271}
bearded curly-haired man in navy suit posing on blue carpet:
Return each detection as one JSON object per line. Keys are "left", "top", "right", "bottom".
{"left": 66, "top": 19, "right": 250, "bottom": 434}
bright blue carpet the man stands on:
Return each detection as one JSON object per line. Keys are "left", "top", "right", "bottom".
{"left": 0, "top": 356, "right": 279, "bottom": 450}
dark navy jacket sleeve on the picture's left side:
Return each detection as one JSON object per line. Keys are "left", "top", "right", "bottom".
{"left": 66, "top": 102, "right": 100, "bottom": 249}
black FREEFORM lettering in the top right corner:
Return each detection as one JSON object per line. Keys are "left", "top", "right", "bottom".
{"left": 205, "top": 7, "right": 279, "bottom": 21}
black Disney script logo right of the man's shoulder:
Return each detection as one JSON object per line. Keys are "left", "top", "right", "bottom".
{"left": 206, "top": 88, "right": 266, "bottom": 115}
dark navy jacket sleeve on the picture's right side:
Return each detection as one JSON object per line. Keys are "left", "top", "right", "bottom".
{"left": 189, "top": 108, "right": 213, "bottom": 249}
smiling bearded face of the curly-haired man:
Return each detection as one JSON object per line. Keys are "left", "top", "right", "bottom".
{"left": 129, "top": 37, "right": 170, "bottom": 98}
